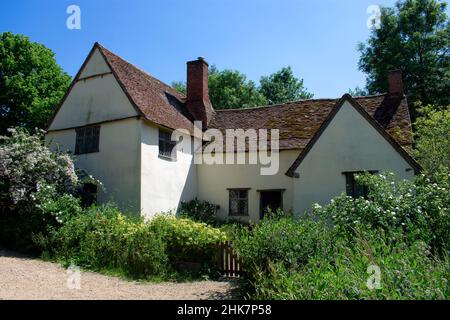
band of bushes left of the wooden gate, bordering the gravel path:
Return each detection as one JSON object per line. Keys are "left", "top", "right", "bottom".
{"left": 0, "top": 129, "right": 225, "bottom": 279}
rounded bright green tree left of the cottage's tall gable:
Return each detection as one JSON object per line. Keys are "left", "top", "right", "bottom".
{"left": 0, "top": 32, "right": 70, "bottom": 133}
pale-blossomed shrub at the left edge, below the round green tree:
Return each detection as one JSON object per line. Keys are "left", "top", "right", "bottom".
{"left": 0, "top": 129, "right": 78, "bottom": 214}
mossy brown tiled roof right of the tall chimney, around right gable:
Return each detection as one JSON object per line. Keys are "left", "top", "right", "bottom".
{"left": 210, "top": 95, "right": 413, "bottom": 150}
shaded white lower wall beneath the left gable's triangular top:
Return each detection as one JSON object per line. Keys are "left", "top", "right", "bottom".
{"left": 46, "top": 118, "right": 141, "bottom": 213}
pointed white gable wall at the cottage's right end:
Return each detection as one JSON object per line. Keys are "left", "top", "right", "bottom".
{"left": 293, "top": 102, "right": 414, "bottom": 214}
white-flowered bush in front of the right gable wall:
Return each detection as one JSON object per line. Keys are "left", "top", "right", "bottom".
{"left": 314, "top": 170, "right": 450, "bottom": 255}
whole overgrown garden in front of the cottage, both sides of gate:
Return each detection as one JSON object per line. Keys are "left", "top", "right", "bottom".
{"left": 0, "top": 104, "right": 450, "bottom": 299}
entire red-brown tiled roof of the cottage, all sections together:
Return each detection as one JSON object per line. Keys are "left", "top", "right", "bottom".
{"left": 55, "top": 43, "right": 413, "bottom": 156}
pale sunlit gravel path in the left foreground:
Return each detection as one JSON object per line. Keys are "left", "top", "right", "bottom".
{"left": 0, "top": 248, "right": 237, "bottom": 300}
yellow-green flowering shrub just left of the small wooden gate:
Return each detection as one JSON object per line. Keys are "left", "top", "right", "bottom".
{"left": 149, "top": 215, "right": 226, "bottom": 266}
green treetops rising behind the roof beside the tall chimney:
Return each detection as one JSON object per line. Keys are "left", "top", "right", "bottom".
{"left": 172, "top": 66, "right": 313, "bottom": 109}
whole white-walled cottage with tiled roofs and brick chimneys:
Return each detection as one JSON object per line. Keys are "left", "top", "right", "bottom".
{"left": 46, "top": 43, "right": 419, "bottom": 221}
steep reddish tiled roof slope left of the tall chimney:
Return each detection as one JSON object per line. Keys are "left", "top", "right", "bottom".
{"left": 95, "top": 43, "right": 192, "bottom": 131}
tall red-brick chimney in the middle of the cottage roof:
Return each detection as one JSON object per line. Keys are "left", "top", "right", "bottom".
{"left": 186, "top": 57, "right": 213, "bottom": 127}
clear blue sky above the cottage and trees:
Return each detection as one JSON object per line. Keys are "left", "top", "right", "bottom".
{"left": 0, "top": 0, "right": 395, "bottom": 98}
